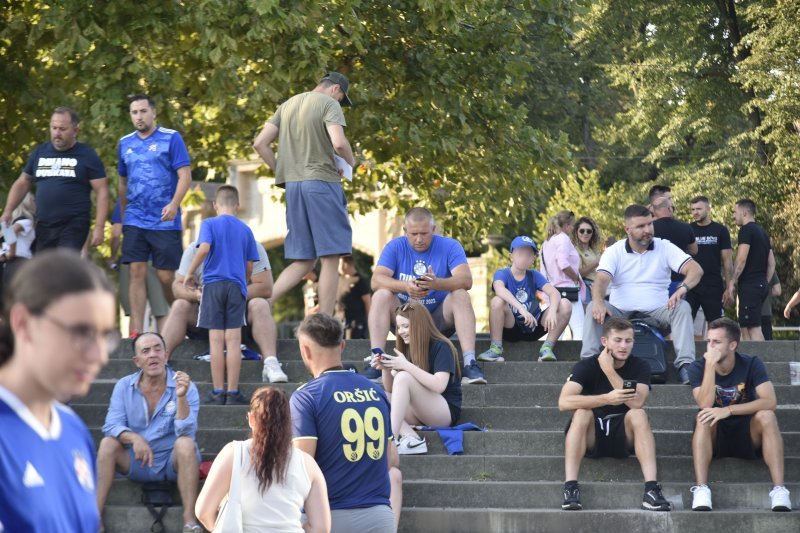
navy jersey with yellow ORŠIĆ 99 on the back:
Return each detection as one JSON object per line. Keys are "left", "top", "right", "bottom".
{"left": 290, "top": 370, "right": 394, "bottom": 509}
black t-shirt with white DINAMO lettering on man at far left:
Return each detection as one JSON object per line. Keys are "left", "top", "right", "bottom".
{"left": 23, "top": 142, "right": 106, "bottom": 224}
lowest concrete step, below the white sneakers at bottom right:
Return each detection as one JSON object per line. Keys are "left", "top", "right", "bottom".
{"left": 398, "top": 502, "right": 800, "bottom": 533}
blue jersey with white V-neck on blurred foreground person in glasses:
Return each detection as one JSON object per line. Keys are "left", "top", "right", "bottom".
{"left": 0, "top": 387, "right": 100, "bottom": 533}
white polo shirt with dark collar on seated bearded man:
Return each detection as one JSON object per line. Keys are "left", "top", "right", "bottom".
{"left": 597, "top": 238, "right": 692, "bottom": 312}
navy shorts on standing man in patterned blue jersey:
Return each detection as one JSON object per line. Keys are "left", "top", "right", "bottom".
{"left": 121, "top": 226, "right": 183, "bottom": 270}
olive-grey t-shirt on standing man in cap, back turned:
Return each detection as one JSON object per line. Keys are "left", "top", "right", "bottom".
{"left": 267, "top": 91, "right": 347, "bottom": 186}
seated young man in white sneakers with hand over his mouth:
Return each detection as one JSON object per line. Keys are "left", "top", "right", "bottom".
{"left": 689, "top": 318, "right": 792, "bottom": 511}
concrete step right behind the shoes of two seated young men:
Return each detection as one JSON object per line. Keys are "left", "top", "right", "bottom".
{"left": 403, "top": 477, "right": 800, "bottom": 510}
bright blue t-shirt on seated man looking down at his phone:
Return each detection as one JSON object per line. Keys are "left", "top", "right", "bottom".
{"left": 378, "top": 235, "right": 467, "bottom": 313}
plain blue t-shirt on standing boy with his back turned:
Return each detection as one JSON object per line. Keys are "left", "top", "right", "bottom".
{"left": 197, "top": 215, "right": 258, "bottom": 299}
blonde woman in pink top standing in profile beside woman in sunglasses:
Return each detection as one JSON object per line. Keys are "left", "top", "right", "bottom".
{"left": 542, "top": 211, "right": 585, "bottom": 340}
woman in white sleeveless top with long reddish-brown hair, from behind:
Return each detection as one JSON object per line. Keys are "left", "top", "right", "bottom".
{"left": 195, "top": 387, "right": 331, "bottom": 533}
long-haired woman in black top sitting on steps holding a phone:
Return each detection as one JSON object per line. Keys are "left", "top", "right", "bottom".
{"left": 373, "top": 301, "right": 461, "bottom": 455}
